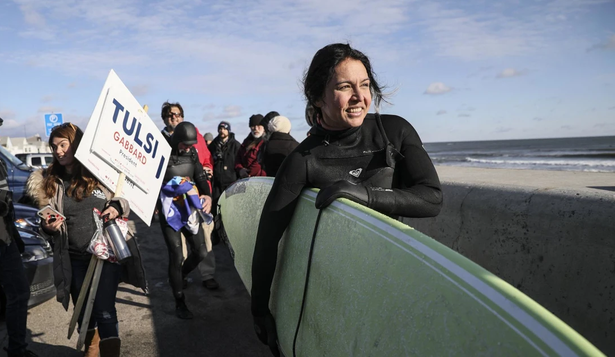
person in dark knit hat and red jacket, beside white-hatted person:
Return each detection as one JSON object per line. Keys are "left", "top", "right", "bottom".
{"left": 235, "top": 114, "right": 267, "bottom": 178}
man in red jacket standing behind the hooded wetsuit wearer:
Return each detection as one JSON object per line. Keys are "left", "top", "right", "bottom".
{"left": 160, "top": 102, "right": 219, "bottom": 290}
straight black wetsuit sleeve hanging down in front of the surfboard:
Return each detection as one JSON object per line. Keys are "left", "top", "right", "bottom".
{"left": 251, "top": 152, "right": 307, "bottom": 316}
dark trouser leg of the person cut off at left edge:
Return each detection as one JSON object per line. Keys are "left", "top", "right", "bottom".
{"left": 0, "top": 239, "right": 30, "bottom": 354}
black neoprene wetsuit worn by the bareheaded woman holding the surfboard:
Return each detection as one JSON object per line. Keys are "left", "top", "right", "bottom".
{"left": 252, "top": 114, "right": 442, "bottom": 316}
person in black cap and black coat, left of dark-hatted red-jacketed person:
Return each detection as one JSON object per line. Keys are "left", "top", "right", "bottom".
{"left": 208, "top": 121, "right": 241, "bottom": 216}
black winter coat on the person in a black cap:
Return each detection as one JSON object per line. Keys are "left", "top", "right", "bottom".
{"left": 208, "top": 133, "right": 241, "bottom": 187}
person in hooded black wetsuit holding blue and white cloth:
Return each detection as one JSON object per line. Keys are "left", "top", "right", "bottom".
{"left": 158, "top": 122, "right": 211, "bottom": 319}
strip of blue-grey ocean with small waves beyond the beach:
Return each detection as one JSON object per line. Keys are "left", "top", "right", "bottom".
{"left": 424, "top": 136, "right": 615, "bottom": 172}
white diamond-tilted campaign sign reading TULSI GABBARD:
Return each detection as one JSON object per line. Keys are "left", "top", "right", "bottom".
{"left": 75, "top": 70, "right": 171, "bottom": 225}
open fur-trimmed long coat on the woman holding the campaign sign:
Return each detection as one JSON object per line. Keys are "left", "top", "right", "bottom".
{"left": 26, "top": 169, "right": 148, "bottom": 310}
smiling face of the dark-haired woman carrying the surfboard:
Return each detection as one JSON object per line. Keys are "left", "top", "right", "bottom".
{"left": 316, "top": 58, "right": 372, "bottom": 130}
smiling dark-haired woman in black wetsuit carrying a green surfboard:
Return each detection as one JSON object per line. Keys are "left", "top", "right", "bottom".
{"left": 252, "top": 44, "right": 442, "bottom": 354}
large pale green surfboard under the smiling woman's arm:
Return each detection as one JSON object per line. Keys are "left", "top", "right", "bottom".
{"left": 220, "top": 178, "right": 603, "bottom": 356}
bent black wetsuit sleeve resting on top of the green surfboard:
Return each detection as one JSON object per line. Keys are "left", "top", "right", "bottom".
{"left": 368, "top": 116, "right": 442, "bottom": 218}
